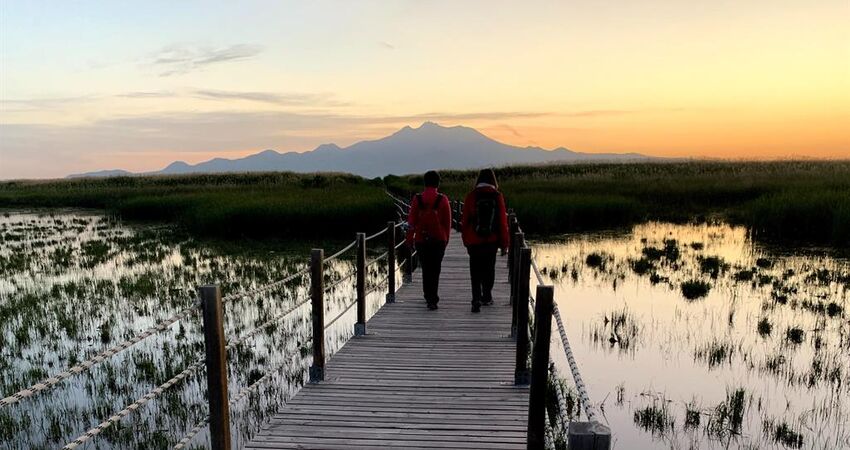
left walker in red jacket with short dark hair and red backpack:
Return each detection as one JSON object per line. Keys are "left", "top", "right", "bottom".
{"left": 406, "top": 170, "right": 452, "bottom": 310}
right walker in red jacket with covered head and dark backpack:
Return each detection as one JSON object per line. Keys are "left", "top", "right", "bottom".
{"left": 461, "top": 169, "right": 510, "bottom": 313}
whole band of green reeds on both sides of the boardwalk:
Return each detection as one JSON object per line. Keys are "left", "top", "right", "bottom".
{"left": 0, "top": 161, "right": 850, "bottom": 246}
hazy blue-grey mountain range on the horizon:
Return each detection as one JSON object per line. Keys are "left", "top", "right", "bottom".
{"left": 69, "top": 122, "right": 652, "bottom": 178}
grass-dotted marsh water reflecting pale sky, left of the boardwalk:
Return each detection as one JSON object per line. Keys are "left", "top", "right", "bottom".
{"left": 0, "top": 212, "right": 394, "bottom": 449}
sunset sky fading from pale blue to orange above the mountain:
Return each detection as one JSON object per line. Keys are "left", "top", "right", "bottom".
{"left": 0, "top": 0, "right": 850, "bottom": 179}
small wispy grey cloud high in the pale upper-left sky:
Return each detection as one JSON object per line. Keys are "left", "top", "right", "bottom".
{"left": 147, "top": 44, "right": 263, "bottom": 77}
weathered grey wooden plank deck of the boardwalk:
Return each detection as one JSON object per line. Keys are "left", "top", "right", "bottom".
{"left": 247, "top": 233, "right": 528, "bottom": 450}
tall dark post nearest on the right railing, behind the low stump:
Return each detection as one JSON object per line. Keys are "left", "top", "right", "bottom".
{"left": 528, "top": 286, "right": 554, "bottom": 450}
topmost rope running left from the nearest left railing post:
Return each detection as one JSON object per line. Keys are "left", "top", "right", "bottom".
{"left": 0, "top": 302, "right": 200, "bottom": 408}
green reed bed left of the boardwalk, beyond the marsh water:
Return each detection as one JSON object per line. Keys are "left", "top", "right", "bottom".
{"left": 0, "top": 173, "right": 394, "bottom": 239}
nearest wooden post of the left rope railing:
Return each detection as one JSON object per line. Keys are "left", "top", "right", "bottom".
{"left": 200, "top": 286, "right": 230, "bottom": 450}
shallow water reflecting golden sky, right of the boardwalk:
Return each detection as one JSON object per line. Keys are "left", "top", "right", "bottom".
{"left": 534, "top": 223, "right": 850, "bottom": 449}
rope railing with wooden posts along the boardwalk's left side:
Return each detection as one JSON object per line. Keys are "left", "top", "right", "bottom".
{"left": 8, "top": 198, "right": 416, "bottom": 449}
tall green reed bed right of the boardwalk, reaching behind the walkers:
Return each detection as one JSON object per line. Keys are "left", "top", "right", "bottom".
{"left": 386, "top": 161, "right": 850, "bottom": 248}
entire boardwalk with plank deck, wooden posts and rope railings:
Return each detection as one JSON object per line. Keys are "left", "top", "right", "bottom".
{"left": 0, "top": 193, "right": 611, "bottom": 450}
